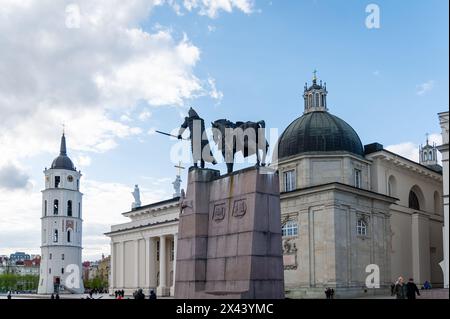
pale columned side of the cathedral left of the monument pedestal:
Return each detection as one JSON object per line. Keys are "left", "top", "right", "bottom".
{"left": 106, "top": 198, "right": 179, "bottom": 296}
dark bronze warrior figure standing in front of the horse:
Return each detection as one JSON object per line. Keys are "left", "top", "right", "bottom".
{"left": 178, "top": 107, "right": 217, "bottom": 168}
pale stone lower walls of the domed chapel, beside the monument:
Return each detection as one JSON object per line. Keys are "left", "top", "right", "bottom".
{"left": 281, "top": 185, "right": 390, "bottom": 298}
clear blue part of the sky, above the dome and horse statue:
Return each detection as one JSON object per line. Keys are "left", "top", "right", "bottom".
{"left": 98, "top": 1, "right": 448, "bottom": 184}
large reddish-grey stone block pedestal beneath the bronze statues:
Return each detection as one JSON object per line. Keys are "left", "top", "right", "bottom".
{"left": 175, "top": 168, "right": 284, "bottom": 299}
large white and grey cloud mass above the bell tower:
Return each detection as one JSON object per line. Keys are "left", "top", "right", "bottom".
{"left": 0, "top": 0, "right": 207, "bottom": 164}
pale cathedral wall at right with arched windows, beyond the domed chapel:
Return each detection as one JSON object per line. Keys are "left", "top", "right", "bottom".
{"left": 369, "top": 156, "right": 443, "bottom": 286}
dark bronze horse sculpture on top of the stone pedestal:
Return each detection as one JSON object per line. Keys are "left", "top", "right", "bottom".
{"left": 211, "top": 119, "right": 269, "bottom": 173}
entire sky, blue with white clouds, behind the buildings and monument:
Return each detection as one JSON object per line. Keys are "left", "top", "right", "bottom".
{"left": 0, "top": 0, "right": 449, "bottom": 259}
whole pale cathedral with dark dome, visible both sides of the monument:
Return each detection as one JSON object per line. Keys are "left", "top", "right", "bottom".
{"left": 106, "top": 76, "right": 448, "bottom": 298}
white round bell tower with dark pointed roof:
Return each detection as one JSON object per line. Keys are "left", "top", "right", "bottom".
{"left": 38, "top": 133, "right": 84, "bottom": 294}
